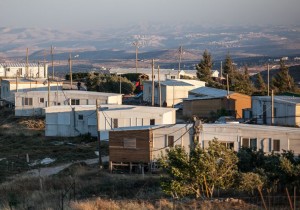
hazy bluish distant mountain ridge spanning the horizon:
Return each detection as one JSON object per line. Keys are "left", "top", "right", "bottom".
{"left": 0, "top": 24, "right": 300, "bottom": 59}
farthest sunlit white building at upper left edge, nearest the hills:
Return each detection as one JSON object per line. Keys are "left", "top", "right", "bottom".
{"left": 0, "top": 63, "right": 48, "bottom": 78}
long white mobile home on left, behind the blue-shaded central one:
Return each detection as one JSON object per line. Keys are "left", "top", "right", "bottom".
{"left": 15, "top": 90, "right": 122, "bottom": 116}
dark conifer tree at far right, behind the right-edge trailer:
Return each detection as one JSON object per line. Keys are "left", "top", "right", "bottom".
{"left": 272, "top": 60, "right": 295, "bottom": 93}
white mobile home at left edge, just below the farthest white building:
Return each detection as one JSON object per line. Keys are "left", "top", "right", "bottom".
{"left": 1, "top": 78, "right": 63, "bottom": 103}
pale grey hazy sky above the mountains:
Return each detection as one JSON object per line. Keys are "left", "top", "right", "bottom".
{"left": 0, "top": 0, "right": 300, "bottom": 30}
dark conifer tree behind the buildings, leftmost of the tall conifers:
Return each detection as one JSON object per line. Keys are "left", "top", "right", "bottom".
{"left": 196, "top": 50, "right": 213, "bottom": 83}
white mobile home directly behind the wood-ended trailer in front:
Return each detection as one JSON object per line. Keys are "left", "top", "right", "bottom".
{"left": 44, "top": 105, "right": 176, "bottom": 139}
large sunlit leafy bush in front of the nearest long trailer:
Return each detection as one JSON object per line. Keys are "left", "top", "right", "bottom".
{"left": 160, "top": 139, "right": 238, "bottom": 198}
